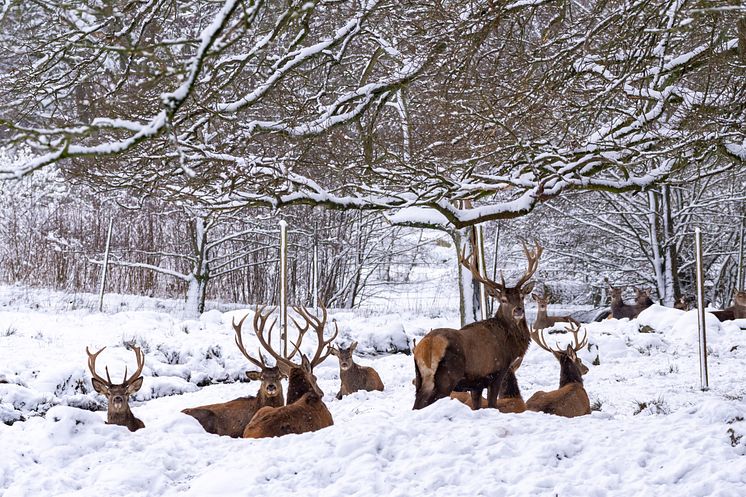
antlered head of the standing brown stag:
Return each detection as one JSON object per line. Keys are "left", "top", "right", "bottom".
{"left": 461, "top": 242, "right": 544, "bottom": 322}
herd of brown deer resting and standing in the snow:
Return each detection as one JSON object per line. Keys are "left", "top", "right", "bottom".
{"left": 86, "top": 243, "right": 746, "bottom": 438}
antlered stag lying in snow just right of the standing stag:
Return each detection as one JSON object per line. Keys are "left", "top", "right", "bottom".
{"left": 526, "top": 326, "right": 591, "bottom": 418}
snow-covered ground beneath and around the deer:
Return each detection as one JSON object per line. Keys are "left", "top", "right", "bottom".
{"left": 0, "top": 287, "right": 746, "bottom": 497}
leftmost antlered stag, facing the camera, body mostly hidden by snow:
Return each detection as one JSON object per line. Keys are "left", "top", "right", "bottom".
{"left": 85, "top": 347, "right": 145, "bottom": 431}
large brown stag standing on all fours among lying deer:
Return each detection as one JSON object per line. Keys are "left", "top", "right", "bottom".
{"left": 413, "top": 239, "right": 543, "bottom": 409}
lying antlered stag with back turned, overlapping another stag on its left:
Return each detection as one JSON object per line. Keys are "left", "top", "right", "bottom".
{"left": 243, "top": 307, "right": 339, "bottom": 438}
